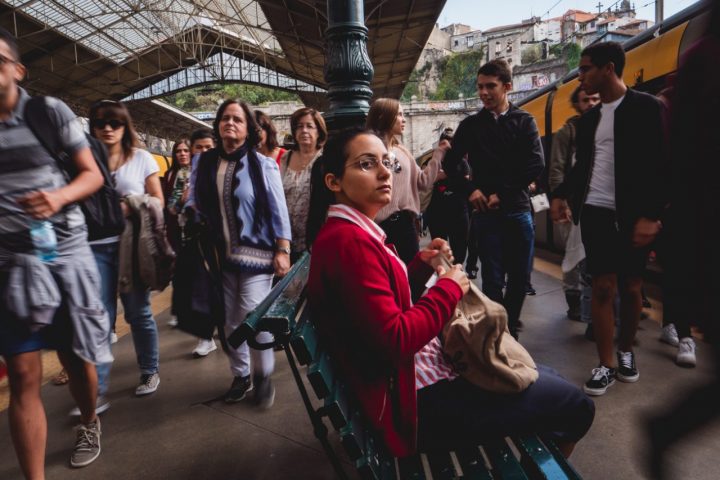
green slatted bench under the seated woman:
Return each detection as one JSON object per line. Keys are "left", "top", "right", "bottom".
{"left": 228, "top": 254, "right": 581, "bottom": 480}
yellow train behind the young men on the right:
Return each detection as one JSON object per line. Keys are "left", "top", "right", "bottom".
{"left": 518, "top": 2, "right": 709, "bottom": 249}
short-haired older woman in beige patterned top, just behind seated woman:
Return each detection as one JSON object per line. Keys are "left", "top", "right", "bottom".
{"left": 280, "top": 108, "right": 327, "bottom": 261}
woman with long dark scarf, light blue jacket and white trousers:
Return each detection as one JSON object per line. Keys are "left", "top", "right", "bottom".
{"left": 188, "top": 100, "right": 291, "bottom": 408}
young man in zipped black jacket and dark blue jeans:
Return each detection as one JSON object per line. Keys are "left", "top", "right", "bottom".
{"left": 444, "top": 60, "right": 545, "bottom": 338}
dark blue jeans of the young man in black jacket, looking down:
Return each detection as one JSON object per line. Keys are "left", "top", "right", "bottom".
{"left": 475, "top": 212, "right": 535, "bottom": 336}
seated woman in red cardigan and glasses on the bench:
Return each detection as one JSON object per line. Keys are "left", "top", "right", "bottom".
{"left": 308, "top": 129, "right": 595, "bottom": 456}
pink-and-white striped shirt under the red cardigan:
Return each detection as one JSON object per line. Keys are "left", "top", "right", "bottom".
{"left": 328, "top": 204, "right": 457, "bottom": 390}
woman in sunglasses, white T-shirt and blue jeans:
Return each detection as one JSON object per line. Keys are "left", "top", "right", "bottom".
{"left": 89, "top": 100, "right": 164, "bottom": 396}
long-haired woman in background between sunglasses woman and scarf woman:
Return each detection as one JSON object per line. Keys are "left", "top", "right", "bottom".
{"left": 162, "top": 137, "right": 192, "bottom": 252}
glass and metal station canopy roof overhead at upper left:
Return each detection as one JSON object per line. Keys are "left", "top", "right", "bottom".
{"left": 0, "top": 0, "right": 445, "bottom": 138}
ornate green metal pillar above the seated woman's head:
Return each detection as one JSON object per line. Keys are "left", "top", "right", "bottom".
{"left": 325, "top": 0, "right": 374, "bottom": 132}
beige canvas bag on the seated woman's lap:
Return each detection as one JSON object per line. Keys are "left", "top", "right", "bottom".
{"left": 442, "top": 261, "right": 538, "bottom": 393}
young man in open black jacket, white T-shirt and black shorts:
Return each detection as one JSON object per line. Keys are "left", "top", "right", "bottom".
{"left": 551, "top": 42, "right": 665, "bottom": 395}
